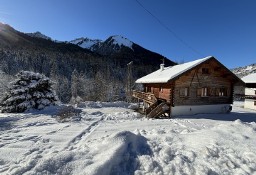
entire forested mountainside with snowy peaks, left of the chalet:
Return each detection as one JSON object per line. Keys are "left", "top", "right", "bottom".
{"left": 0, "top": 23, "right": 175, "bottom": 103}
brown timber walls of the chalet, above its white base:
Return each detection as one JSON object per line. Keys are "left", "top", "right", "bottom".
{"left": 134, "top": 57, "right": 241, "bottom": 118}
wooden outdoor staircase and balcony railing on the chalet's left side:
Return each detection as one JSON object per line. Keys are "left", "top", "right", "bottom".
{"left": 132, "top": 91, "right": 170, "bottom": 118}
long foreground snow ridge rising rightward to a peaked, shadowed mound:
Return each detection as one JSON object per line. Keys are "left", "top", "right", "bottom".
{"left": 22, "top": 131, "right": 152, "bottom": 175}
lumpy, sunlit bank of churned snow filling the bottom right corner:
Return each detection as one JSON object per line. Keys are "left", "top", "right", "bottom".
{"left": 135, "top": 120, "right": 256, "bottom": 174}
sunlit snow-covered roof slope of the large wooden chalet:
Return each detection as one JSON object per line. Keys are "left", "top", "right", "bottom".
{"left": 136, "top": 56, "right": 213, "bottom": 83}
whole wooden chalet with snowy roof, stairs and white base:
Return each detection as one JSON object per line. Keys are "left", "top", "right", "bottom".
{"left": 133, "top": 56, "right": 243, "bottom": 117}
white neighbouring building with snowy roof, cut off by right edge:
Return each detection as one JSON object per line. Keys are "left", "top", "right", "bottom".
{"left": 242, "top": 73, "right": 256, "bottom": 110}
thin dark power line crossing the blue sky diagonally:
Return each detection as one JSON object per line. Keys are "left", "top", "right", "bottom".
{"left": 135, "top": 0, "right": 203, "bottom": 56}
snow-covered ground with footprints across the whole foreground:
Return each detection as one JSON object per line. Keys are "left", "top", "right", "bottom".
{"left": 0, "top": 102, "right": 256, "bottom": 175}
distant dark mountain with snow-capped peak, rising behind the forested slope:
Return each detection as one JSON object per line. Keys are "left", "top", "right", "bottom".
{"left": 70, "top": 35, "right": 175, "bottom": 70}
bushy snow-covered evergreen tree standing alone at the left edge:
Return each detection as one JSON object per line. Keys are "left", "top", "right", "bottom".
{"left": 0, "top": 71, "right": 58, "bottom": 112}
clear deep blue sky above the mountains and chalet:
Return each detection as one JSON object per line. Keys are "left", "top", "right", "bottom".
{"left": 0, "top": 0, "right": 256, "bottom": 68}
